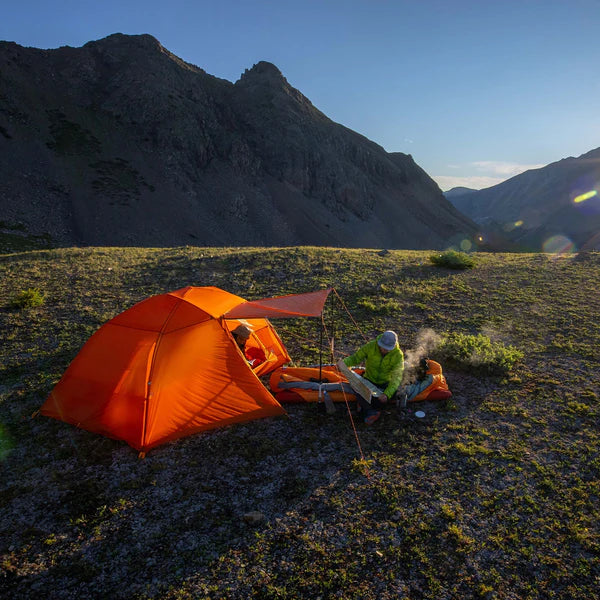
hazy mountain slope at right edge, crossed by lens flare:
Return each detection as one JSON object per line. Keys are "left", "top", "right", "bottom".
{"left": 447, "top": 148, "right": 600, "bottom": 251}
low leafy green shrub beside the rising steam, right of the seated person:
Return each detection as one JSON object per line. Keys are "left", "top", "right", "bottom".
{"left": 436, "top": 333, "right": 523, "bottom": 375}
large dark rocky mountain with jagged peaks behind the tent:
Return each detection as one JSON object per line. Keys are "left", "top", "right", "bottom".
{"left": 0, "top": 34, "right": 477, "bottom": 249}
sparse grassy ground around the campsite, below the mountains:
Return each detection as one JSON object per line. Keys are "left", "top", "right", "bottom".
{"left": 0, "top": 247, "right": 600, "bottom": 600}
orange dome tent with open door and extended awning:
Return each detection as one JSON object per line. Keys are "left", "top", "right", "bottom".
{"left": 40, "top": 287, "right": 330, "bottom": 452}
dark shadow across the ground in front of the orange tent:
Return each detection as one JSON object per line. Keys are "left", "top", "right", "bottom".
{"left": 0, "top": 398, "right": 364, "bottom": 598}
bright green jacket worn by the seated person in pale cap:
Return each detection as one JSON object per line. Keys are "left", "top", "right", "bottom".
{"left": 344, "top": 335, "right": 404, "bottom": 398}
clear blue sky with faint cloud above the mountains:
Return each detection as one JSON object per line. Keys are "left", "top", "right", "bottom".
{"left": 0, "top": 0, "right": 600, "bottom": 190}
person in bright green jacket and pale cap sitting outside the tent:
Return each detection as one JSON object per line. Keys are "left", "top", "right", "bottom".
{"left": 344, "top": 331, "right": 404, "bottom": 425}
